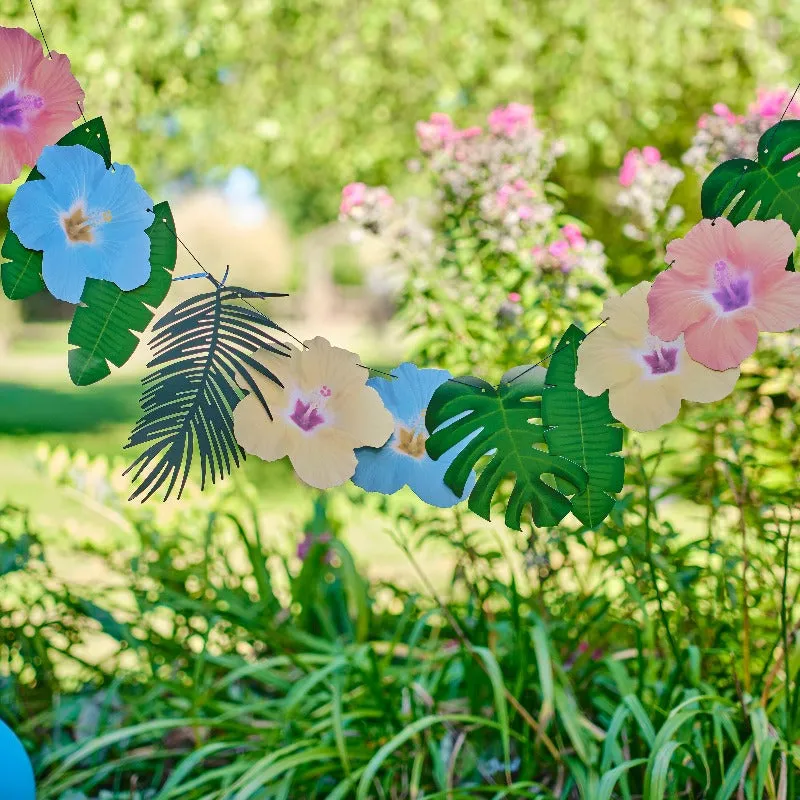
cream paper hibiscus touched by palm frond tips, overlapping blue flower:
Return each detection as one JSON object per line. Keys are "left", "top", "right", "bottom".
{"left": 233, "top": 336, "right": 394, "bottom": 489}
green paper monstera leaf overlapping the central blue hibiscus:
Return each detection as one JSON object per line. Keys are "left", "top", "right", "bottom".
{"left": 425, "top": 367, "right": 588, "bottom": 531}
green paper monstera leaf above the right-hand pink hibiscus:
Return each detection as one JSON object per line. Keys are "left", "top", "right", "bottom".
{"left": 700, "top": 120, "right": 800, "bottom": 271}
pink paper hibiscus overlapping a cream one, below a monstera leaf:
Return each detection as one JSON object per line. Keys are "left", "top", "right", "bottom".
{"left": 647, "top": 217, "right": 800, "bottom": 370}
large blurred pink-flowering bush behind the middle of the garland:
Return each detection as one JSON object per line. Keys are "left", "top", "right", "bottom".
{"left": 340, "top": 103, "right": 611, "bottom": 384}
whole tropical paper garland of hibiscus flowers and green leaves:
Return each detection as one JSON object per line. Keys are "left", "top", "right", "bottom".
{"left": 0, "top": 28, "right": 800, "bottom": 530}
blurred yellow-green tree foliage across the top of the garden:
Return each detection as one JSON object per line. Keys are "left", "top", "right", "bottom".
{"left": 0, "top": 0, "right": 800, "bottom": 244}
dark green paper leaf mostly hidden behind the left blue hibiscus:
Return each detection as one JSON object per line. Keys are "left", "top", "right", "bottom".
{"left": 0, "top": 117, "right": 111, "bottom": 300}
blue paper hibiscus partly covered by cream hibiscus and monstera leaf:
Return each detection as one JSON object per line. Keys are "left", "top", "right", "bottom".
{"left": 352, "top": 362, "right": 479, "bottom": 508}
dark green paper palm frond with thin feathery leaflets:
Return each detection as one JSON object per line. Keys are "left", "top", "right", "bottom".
{"left": 125, "top": 284, "right": 289, "bottom": 502}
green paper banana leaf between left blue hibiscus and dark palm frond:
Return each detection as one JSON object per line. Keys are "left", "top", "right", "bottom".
{"left": 67, "top": 203, "right": 178, "bottom": 386}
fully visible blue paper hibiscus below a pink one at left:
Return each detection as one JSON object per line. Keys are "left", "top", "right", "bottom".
{"left": 8, "top": 145, "right": 155, "bottom": 303}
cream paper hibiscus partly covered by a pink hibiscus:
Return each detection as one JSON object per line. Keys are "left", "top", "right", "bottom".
{"left": 575, "top": 281, "right": 739, "bottom": 431}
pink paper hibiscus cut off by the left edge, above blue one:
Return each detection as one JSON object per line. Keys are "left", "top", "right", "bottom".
{"left": 0, "top": 28, "right": 84, "bottom": 183}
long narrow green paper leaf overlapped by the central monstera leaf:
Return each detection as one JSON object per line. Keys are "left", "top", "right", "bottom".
{"left": 542, "top": 325, "right": 625, "bottom": 528}
